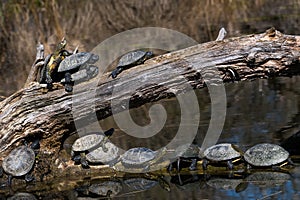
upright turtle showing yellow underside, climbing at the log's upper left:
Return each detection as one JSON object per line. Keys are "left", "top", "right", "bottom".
{"left": 39, "top": 38, "right": 71, "bottom": 89}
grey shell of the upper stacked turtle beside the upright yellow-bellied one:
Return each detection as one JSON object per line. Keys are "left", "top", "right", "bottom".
{"left": 57, "top": 52, "right": 99, "bottom": 72}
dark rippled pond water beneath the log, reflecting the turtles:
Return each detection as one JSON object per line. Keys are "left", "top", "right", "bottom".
{"left": 0, "top": 76, "right": 300, "bottom": 199}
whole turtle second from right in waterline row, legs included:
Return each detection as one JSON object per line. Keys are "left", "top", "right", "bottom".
{"left": 202, "top": 143, "right": 242, "bottom": 170}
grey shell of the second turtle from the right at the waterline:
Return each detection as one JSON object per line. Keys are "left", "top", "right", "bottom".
{"left": 204, "top": 143, "right": 241, "bottom": 161}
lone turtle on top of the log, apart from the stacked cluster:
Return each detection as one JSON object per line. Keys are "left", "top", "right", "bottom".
{"left": 109, "top": 50, "right": 153, "bottom": 79}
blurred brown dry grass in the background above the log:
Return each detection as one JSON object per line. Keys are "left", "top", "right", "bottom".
{"left": 0, "top": 0, "right": 300, "bottom": 95}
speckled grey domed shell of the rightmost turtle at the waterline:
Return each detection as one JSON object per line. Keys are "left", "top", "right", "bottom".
{"left": 244, "top": 143, "right": 289, "bottom": 167}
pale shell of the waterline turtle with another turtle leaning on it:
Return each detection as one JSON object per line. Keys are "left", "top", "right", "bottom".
{"left": 86, "top": 142, "right": 119, "bottom": 165}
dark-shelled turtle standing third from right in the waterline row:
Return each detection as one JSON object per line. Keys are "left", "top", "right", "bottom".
{"left": 168, "top": 144, "right": 201, "bottom": 171}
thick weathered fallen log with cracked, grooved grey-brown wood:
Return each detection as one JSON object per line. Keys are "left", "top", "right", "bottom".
{"left": 0, "top": 29, "right": 300, "bottom": 175}
